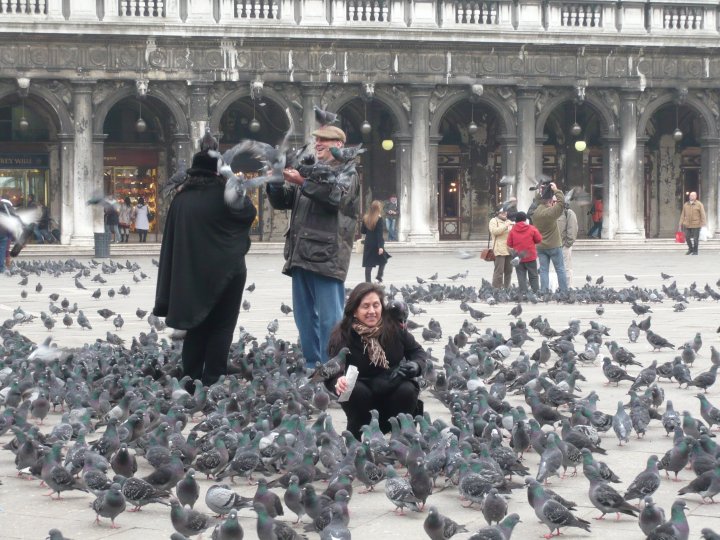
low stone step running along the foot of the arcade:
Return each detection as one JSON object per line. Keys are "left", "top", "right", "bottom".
{"left": 14, "top": 238, "right": 720, "bottom": 259}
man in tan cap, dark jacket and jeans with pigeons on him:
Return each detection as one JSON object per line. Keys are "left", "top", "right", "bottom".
{"left": 267, "top": 126, "right": 360, "bottom": 368}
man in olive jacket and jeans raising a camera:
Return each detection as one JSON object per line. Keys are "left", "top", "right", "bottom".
{"left": 532, "top": 182, "right": 567, "bottom": 292}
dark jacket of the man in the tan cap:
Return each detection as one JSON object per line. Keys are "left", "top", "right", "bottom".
{"left": 267, "top": 174, "right": 360, "bottom": 281}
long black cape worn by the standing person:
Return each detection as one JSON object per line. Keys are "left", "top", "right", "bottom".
{"left": 153, "top": 177, "right": 257, "bottom": 330}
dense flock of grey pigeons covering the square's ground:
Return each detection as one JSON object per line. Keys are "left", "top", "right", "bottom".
{"left": 0, "top": 254, "right": 720, "bottom": 540}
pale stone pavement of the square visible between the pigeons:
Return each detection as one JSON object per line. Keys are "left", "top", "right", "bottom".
{"left": 0, "top": 250, "right": 720, "bottom": 540}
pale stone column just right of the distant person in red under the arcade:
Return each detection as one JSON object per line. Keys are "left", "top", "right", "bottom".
{"left": 616, "top": 90, "right": 645, "bottom": 239}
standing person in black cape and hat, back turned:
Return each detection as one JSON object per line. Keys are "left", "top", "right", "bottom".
{"left": 153, "top": 146, "right": 257, "bottom": 386}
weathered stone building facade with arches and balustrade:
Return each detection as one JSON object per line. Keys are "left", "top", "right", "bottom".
{"left": 0, "top": 0, "right": 720, "bottom": 245}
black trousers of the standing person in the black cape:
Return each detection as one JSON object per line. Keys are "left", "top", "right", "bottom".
{"left": 182, "top": 272, "right": 247, "bottom": 386}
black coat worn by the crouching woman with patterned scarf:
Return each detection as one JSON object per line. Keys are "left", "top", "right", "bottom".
{"left": 325, "top": 328, "right": 427, "bottom": 391}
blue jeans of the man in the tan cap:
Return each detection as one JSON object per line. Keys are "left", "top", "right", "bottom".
{"left": 292, "top": 268, "right": 345, "bottom": 368}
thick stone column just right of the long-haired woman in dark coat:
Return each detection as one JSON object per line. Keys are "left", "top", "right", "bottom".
{"left": 408, "top": 85, "right": 437, "bottom": 243}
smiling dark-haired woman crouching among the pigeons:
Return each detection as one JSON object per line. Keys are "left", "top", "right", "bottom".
{"left": 325, "top": 282, "right": 427, "bottom": 440}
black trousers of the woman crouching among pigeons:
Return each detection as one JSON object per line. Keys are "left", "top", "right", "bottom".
{"left": 340, "top": 380, "right": 419, "bottom": 441}
